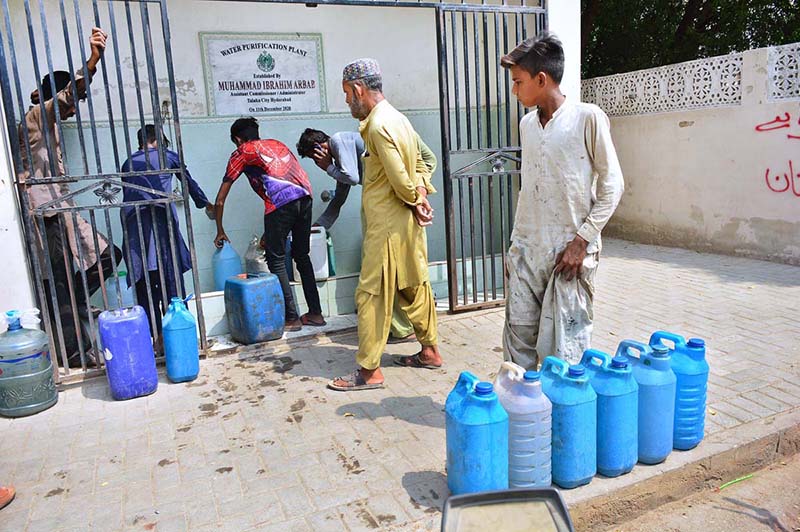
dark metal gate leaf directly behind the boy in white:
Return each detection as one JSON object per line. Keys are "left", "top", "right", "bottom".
{"left": 436, "top": 0, "right": 547, "bottom": 312}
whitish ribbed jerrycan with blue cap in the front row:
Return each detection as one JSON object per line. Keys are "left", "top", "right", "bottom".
{"left": 494, "top": 362, "right": 553, "bottom": 488}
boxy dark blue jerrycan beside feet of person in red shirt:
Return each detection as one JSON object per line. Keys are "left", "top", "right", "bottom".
{"left": 225, "top": 273, "right": 286, "bottom": 345}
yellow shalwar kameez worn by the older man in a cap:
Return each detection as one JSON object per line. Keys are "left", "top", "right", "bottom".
{"left": 356, "top": 100, "right": 437, "bottom": 370}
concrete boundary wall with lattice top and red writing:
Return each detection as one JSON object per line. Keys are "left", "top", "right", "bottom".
{"left": 582, "top": 44, "right": 800, "bottom": 264}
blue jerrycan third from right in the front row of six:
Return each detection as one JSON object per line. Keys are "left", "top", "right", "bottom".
{"left": 581, "top": 349, "right": 639, "bottom": 477}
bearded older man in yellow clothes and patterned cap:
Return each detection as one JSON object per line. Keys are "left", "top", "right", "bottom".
{"left": 328, "top": 59, "right": 442, "bottom": 391}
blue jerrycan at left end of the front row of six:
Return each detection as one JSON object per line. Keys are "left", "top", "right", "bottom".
{"left": 445, "top": 372, "right": 508, "bottom": 495}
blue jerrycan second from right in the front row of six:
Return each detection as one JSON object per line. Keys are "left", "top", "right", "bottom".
{"left": 617, "top": 340, "right": 675, "bottom": 464}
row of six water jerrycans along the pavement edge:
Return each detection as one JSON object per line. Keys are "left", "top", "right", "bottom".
{"left": 445, "top": 331, "right": 708, "bottom": 495}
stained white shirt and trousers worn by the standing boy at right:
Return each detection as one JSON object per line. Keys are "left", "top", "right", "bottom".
{"left": 503, "top": 101, "right": 624, "bottom": 369}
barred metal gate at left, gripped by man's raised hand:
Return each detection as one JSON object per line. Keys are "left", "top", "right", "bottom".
{"left": 0, "top": 0, "right": 207, "bottom": 381}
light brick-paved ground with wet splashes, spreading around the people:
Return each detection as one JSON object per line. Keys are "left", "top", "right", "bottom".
{"left": 0, "top": 241, "right": 800, "bottom": 532}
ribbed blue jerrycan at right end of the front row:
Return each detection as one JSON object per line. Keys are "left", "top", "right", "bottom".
{"left": 650, "top": 331, "right": 708, "bottom": 451}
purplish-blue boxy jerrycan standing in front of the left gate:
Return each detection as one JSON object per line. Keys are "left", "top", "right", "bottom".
{"left": 98, "top": 305, "right": 158, "bottom": 401}
